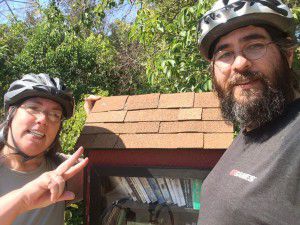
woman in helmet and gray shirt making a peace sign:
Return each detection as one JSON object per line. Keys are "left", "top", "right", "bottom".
{"left": 0, "top": 74, "right": 88, "bottom": 225}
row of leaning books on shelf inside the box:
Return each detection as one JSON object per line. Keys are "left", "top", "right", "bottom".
{"left": 110, "top": 176, "right": 202, "bottom": 210}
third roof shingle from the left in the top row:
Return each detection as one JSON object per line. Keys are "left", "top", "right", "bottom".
{"left": 158, "top": 92, "right": 195, "bottom": 108}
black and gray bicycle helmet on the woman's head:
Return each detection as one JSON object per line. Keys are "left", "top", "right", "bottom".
{"left": 4, "top": 73, "right": 74, "bottom": 119}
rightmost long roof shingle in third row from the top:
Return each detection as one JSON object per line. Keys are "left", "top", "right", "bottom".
{"left": 159, "top": 121, "right": 233, "bottom": 133}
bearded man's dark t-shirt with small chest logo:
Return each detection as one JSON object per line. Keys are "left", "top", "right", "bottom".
{"left": 198, "top": 99, "right": 300, "bottom": 225}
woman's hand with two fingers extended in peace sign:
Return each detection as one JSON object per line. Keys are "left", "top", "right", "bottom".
{"left": 21, "top": 147, "right": 88, "bottom": 211}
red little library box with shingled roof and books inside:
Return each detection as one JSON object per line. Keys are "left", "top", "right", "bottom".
{"left": 77, "top": 92, "right": 233, "bottom": 225}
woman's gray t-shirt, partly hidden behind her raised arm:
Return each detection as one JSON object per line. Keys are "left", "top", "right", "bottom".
{"left": 0, "top": 160, "right": 65, "bottom": 225}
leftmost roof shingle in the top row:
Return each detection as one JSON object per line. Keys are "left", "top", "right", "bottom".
{"left": 92, "top": 95, "right": 128, "bottom": 113}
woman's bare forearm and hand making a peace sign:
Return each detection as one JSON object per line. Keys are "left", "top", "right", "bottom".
{"left": 0, "top": 147, "right": 88, "bottom": 225}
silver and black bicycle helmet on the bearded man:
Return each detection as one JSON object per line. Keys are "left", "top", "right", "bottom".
{"left": 198, "top": 0, "right": 296, "bottom": 59}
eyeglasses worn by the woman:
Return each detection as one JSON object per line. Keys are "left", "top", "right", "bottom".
{"left": 20, "top": 104, "right": 63, "bottom": 123}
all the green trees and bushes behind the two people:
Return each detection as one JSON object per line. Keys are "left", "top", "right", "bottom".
{"left": 0, "top": 0, "right": 300, "bottom": 225}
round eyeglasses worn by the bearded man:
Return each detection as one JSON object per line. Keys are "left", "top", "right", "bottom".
{"left": 213, "top": 41, "right": 274, "bottom": 68}
